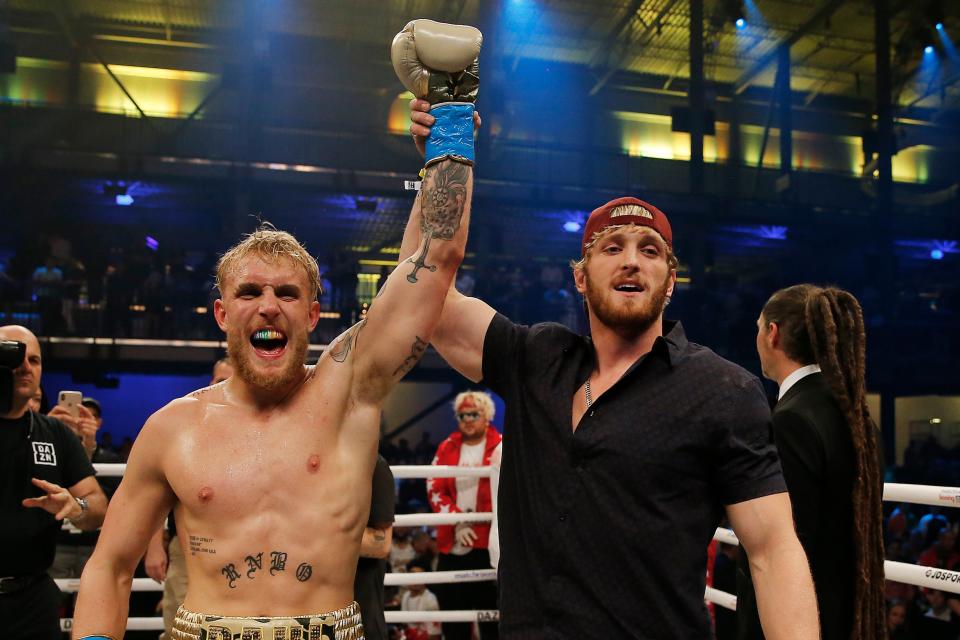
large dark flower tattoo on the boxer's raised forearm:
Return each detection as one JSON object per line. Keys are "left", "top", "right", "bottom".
{"left": 407, "top": 162, "right": 470, "bottom": 283}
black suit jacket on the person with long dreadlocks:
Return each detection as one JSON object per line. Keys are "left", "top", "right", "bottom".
{"left": 737, "top": 373, "right": 856, "bottom": 640}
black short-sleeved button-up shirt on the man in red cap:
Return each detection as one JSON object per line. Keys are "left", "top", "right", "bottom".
{"left": 483, "top": 315, "right": 786, "bottom": 640}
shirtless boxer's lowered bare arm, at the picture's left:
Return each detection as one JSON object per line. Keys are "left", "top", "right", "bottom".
{"left": 73, "top": 410, "right": 174, "bottom": 638}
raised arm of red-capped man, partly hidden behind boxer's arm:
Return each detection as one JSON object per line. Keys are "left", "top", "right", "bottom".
{"left": 400, "top": 99, "right": 496, "bottom": 382}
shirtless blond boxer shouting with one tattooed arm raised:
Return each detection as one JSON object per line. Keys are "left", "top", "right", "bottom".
{"left": 74, "top": 17, "right": 479, "bottom": 640}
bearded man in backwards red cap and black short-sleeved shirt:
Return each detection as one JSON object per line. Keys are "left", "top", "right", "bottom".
{"left": 401, "top": 101, "right": 819, "bottom": 640}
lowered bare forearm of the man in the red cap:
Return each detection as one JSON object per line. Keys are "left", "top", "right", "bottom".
{"left": 727, "top": 493, "right": 820, "bottom": 640}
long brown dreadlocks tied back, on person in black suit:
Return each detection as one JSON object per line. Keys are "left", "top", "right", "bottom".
{"left": 763, "top": 284, "right": 886, "bottom": 640}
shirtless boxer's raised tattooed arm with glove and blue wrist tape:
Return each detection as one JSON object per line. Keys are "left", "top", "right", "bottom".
{"left": 331, "top": 20, "right": 482, "bottom": 403}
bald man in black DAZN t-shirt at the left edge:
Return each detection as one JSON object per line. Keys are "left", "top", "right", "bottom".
{"left": 0, "top": 325, "right": 107, "bottom": 640}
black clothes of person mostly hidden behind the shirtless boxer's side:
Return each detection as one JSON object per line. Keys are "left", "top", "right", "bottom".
{"left": 353, "top": 456, "right": 397, "bottom": 640}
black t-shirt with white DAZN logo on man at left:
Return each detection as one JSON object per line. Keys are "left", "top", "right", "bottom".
{"left": 0, "top": 411, "right": 95, "bottom": 576}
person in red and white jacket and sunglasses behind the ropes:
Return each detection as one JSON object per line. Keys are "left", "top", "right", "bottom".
{"left": 427, "top": 391, "right": 501, "bottom": 640}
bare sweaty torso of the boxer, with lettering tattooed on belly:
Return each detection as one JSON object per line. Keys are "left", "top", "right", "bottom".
{"left": 158, "top": 372, "right": 379, "bottom": 615}
